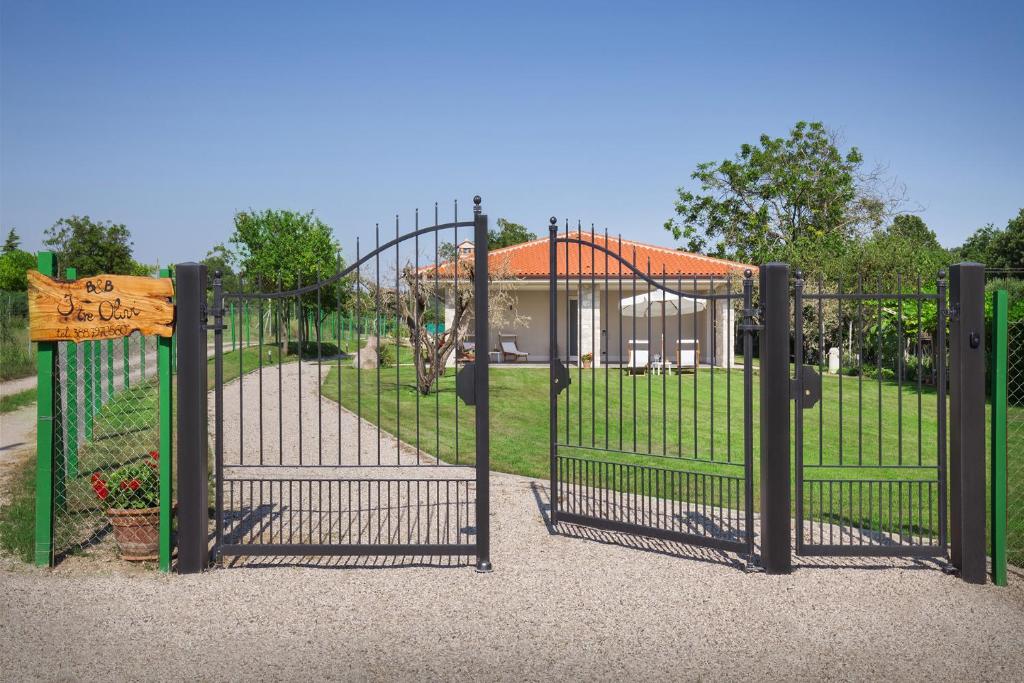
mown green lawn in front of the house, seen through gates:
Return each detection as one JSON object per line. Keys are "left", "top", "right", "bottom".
{"left": 323, "top": 366, "right": 1024, "bottom": 548}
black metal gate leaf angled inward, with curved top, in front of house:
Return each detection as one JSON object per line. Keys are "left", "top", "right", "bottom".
{"left": 549, "top": 218, "right": 756, "bottom": 555}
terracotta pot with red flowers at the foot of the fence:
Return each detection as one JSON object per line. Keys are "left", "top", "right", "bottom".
{"left": 92, "top": 451, "right": 160, "bottom": 562}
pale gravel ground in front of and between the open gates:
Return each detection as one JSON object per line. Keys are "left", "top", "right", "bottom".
{"left": 0, "top": 358, "right": 1024, "bottom": 680}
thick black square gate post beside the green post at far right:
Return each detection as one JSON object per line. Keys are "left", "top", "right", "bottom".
{"left": 939, "top": 263, "right": 985, "bottom": 584}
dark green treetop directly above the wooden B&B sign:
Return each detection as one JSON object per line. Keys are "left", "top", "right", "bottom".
{"left": 44, "top": 216, "right": 140, "bottom": 278}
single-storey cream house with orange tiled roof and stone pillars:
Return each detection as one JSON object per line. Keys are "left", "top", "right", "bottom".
{"left": 439, "top": 231, "right": 757, "bottom": 367}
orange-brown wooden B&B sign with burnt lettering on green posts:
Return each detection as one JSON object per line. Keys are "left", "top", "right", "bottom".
{"left": 28, "top": 270, "right": 174, "bottom": 342}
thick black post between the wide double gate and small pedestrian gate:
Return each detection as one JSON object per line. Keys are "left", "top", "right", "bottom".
{"left": 759, "top": 263, "right": 793, "bottom": 573}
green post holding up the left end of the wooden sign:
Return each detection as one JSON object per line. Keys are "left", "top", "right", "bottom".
{"left": 35, "top": 252, "right": 57, "bottom": 566}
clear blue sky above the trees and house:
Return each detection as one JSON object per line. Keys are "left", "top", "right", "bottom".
{"left": 0, "top": 0, "right": 1024, "bottom": 263}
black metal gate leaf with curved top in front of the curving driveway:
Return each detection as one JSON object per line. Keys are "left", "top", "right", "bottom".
{"left": 212, "top": 197, "right": 490, "bottom": 570}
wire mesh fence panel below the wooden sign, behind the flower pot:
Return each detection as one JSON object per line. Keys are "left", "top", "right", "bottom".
{"left": 53, "top": 334, "right": 160, "bottom": 560}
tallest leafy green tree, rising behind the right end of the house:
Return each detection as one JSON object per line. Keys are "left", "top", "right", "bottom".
{"left": 665, "top": 121, "right": 898, "bottom": 271}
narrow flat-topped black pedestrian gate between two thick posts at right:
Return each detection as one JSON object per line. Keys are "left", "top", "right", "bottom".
{"left": 793, "top": 271, "right": 947, "bottom": 557}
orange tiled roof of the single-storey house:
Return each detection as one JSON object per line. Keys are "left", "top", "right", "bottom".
{"left": 424, "top": 230, "right": 757, "bottom": 280}
